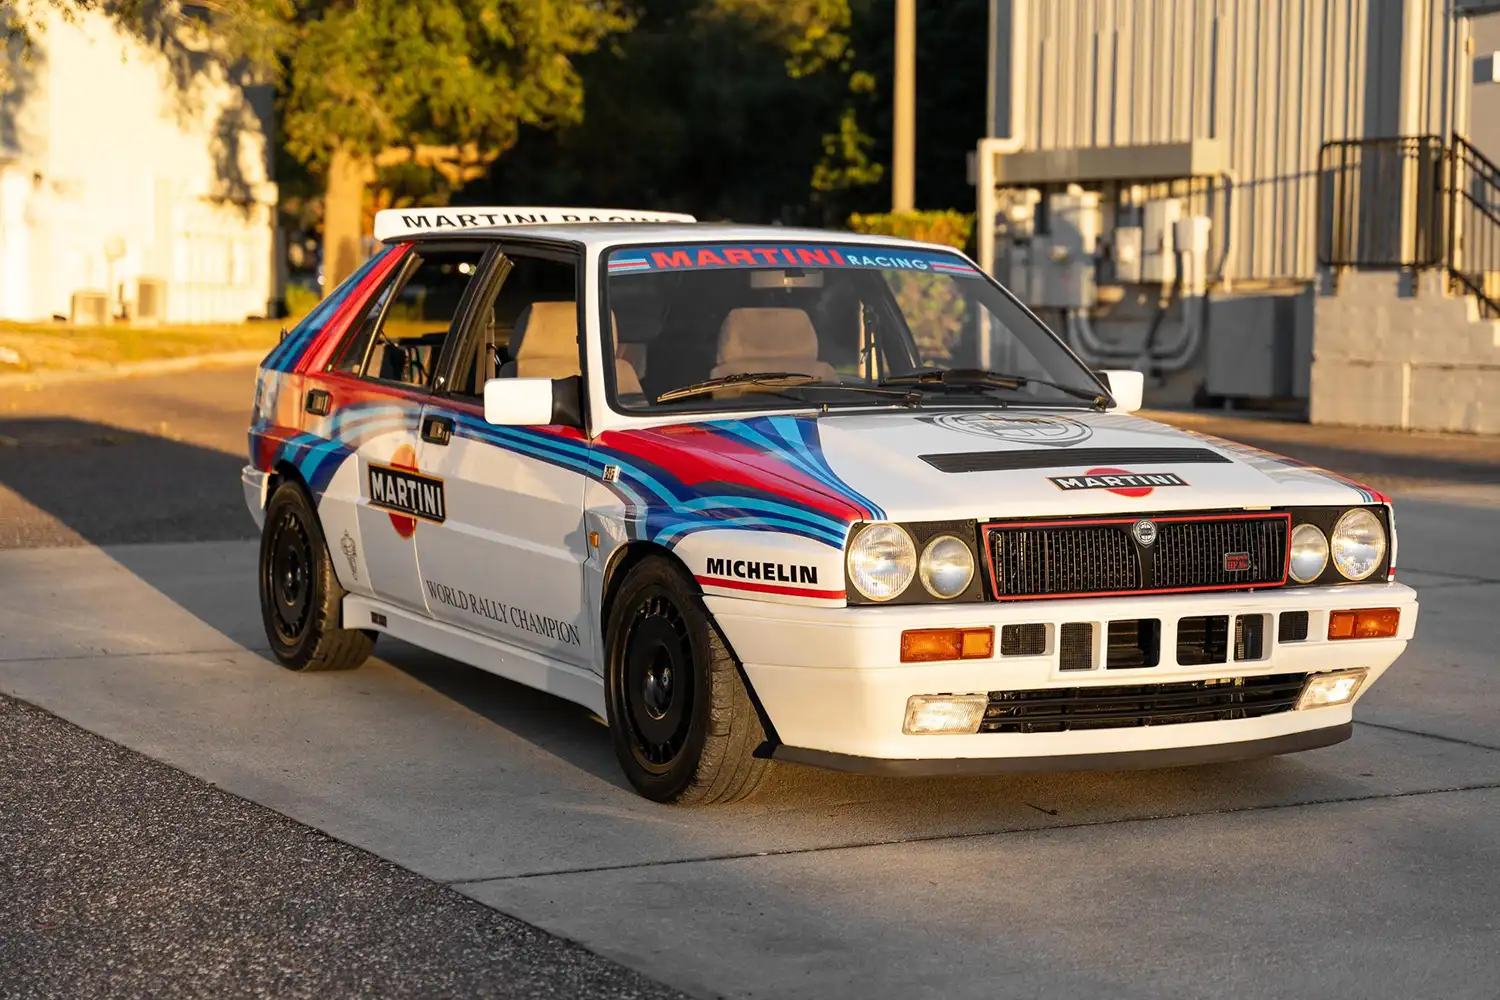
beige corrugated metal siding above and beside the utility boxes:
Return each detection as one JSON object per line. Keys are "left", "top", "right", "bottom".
{"left": 995, "top": 0, "right": 1469, "bottom": 279}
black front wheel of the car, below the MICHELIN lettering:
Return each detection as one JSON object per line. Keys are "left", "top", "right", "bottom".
{"left": 605, "top": 558, "right": 768, "bottom": 802}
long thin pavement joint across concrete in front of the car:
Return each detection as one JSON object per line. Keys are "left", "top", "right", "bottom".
{"left": 440, "top": 779, "right": 1500, "bottom": 889}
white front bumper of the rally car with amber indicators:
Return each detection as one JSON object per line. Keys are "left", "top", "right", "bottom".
{"left": 705, "top": 583, "right": 1418, "bottom": 774}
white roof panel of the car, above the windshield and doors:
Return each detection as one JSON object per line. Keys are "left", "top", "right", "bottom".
{"left": 392, "top": 222, "right": 956, "bottom": 253}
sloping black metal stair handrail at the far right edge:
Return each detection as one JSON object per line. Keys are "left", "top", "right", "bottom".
{"left": 1446, "top": 135, "right": 1500, "bottom": 319}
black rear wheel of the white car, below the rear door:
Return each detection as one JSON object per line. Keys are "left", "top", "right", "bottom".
{"left": 260, "top": 483, "right": 375, "bottom": 670}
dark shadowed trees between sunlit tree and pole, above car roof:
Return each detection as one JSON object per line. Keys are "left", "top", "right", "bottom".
{"left": 474, "top": 0, "right": 849, "bottom": 222}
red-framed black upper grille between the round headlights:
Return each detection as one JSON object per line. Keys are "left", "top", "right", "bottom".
{"left": 984, "top": 514, "right": 1292, "bottom": 600}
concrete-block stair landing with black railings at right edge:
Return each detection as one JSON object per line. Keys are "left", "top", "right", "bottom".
{"left": 1308, "top": 136, "right": 1500, "bottom": 433}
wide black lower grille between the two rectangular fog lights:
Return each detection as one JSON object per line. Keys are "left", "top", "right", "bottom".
{"left": 980, "top": 673, "right": 1307, "bottom": 733}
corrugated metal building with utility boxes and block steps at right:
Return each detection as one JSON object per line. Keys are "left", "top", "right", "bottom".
{"left": 974, "top": 0, "right": 1500, "bottom": 432}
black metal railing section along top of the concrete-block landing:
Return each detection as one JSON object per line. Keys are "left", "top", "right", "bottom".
{"left": 1319, "top": 135, "right": 1448, "bottom": 270}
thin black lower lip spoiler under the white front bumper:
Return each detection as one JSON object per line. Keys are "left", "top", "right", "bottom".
{"left": 771, "top": 723, "right": 1355, "bottom": 778}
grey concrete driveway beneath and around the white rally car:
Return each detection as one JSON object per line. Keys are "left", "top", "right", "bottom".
{"left": 0, "top": 370, "right": 1500, "bottom": 1000}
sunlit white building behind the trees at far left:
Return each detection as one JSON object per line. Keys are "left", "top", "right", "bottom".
{"left": 0, "top": 3, "right": 279, "bottom": 322}
